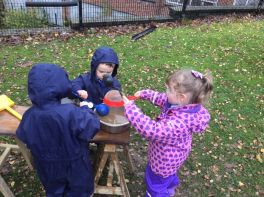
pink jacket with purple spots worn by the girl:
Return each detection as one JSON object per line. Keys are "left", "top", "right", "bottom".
{"left": 125, "top": 90, "right": 210, "bottom": 178}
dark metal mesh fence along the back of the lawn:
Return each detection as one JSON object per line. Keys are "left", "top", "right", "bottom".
{"left": 0, "top": 0, "right": 263, "bottom": 33}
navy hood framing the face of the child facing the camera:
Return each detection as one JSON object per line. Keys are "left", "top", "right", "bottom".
{"left": 91, "top": 46, "right": 119, "bottom": 78}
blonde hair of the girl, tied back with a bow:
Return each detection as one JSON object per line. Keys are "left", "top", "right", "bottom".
{"left": 166, "top": 69, "right": 213, "bottom": 104}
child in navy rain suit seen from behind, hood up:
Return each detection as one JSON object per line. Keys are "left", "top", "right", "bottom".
{"left": 16, "top": 64, "right": 100, "bottom": 197}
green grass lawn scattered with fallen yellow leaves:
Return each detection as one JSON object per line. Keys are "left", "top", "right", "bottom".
{"left": 0, "top": 19, "right": 264, "bottom": 197}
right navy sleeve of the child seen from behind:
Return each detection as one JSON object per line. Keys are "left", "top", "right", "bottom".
{"left": 71, "top": 106, "right": 100, "bottom": 141}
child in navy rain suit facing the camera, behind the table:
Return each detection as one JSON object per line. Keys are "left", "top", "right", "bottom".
{"left": 72, "top": 46, "right": 121, "bottom": 104}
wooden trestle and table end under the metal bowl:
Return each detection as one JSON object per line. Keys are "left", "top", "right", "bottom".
{"left": 91, "top": 130, "right": 134, "bottom": 197}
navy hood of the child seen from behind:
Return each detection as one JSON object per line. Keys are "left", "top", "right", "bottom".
{"left": 28, "top": 63, "right": 71, "bottom": 106}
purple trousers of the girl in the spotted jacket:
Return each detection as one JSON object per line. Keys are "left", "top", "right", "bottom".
{"left": 145, "top": 164, "right": 180, "bottom": 197}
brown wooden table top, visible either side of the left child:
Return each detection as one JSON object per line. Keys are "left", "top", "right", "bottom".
{"left": 0, "top": 105, "right": 130, "bottom": 144}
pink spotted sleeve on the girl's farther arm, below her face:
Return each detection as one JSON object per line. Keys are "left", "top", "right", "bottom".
{"left": 140, "top": 90, "right": 167, "bottom": 107}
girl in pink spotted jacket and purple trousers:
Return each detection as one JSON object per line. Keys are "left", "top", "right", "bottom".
{"left": 124, "top": 69, "right": 213, "bottom": 197}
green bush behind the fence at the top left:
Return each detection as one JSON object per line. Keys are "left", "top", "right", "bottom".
{"left": 3, "top": 9, "right": 48, "bottom": 28}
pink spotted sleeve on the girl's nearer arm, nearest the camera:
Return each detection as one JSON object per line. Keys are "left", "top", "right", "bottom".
{"left": 125, "top": 102, "right": 184, "bottom": 145}
